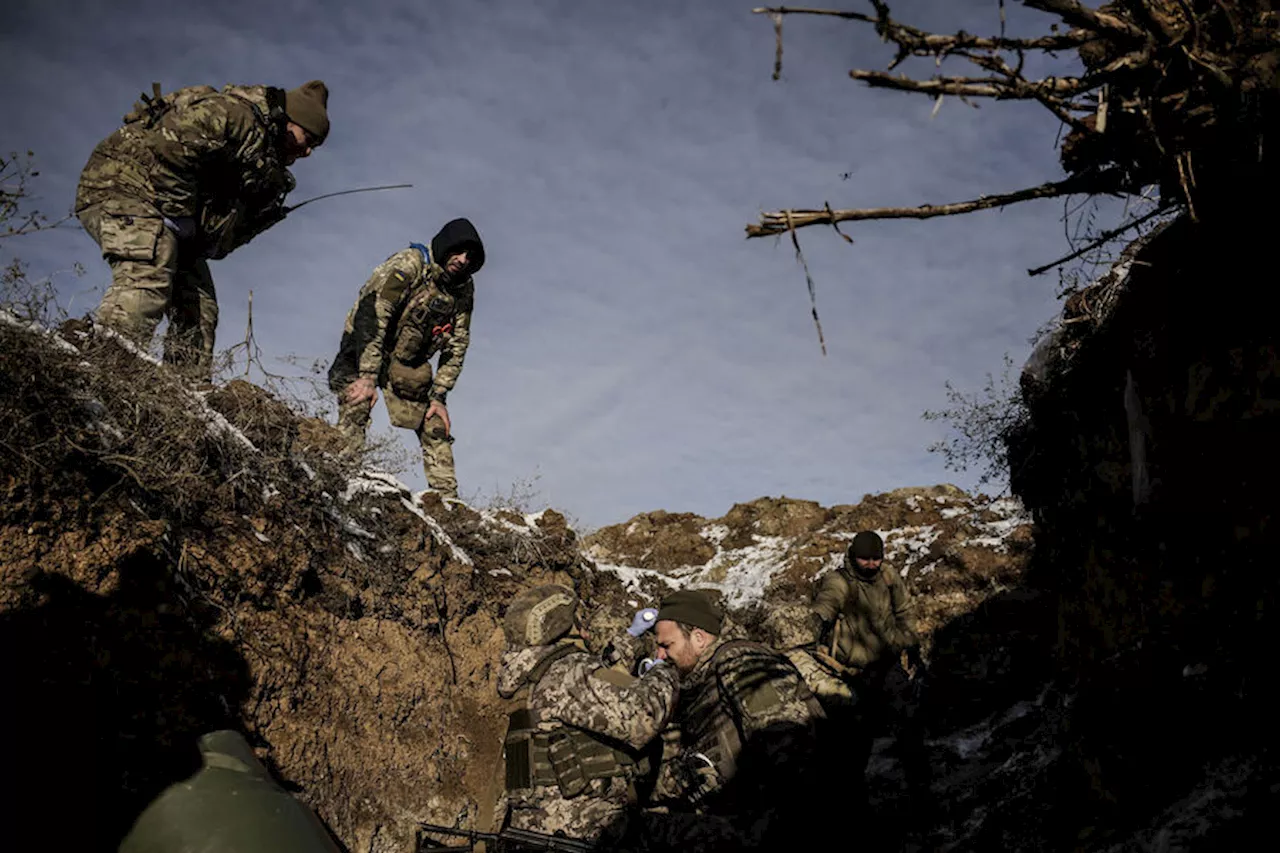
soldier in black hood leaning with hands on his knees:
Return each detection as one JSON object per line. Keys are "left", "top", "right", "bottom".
{"left": 329, "top": 219, "right": 485, "bottom": 500}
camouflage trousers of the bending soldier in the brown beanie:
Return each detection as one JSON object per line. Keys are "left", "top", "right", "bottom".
{"left": 77, "top": 204, "right": 218, "bottom": 379}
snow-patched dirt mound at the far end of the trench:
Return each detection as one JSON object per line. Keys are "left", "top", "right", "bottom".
{"left": 582, "top": 484, "right": 1034, "bottom": 726}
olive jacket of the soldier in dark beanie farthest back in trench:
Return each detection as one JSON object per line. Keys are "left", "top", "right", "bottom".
{"left": 813, "top": 558, "right": 919, "bottom": 669}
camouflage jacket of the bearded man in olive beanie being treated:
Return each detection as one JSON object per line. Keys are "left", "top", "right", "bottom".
{"left": 655, "top": 637, "right": 824, "bottom": 812}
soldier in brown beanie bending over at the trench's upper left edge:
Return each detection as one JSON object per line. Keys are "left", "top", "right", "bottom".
{"left": 76, "top": 81, "right": 329, "bottom": 379}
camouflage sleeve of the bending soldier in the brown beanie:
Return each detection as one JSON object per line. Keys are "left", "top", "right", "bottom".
{"left": 151, "top": 95, "right": 264, "bottom": 219}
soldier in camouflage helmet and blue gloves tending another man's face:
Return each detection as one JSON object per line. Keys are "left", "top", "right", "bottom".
{"left": 498, "top": 584, "right": 678, "bottom": 849}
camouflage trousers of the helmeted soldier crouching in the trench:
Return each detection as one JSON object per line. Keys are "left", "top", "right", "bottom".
{"left": 507, "top": 776, "right": 630, "bottom": 849}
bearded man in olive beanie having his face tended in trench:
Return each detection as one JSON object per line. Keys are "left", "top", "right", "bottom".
{"left": 645, "top": 590, "right": 824, "bottom": 849}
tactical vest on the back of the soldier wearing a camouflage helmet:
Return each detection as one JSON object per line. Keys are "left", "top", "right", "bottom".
{"left": 503, "top": 644, "right": 648, "bottom": 799}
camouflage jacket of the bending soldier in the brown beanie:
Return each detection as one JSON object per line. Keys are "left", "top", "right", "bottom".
{"left": 76, "top": 86, "right": 294, "bottom": 259}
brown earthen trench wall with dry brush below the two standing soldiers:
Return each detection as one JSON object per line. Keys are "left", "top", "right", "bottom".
{"left": 0, "top": 313, "right": 593, "bottom": 852}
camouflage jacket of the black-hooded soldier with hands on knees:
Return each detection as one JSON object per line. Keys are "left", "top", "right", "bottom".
{"left": 330, "top": 246, "right": 475, "bottom": 411}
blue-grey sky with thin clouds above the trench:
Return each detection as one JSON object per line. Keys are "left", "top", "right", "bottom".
{"left": 0, "top": 0, "right": 1100, "bottom": 526}
